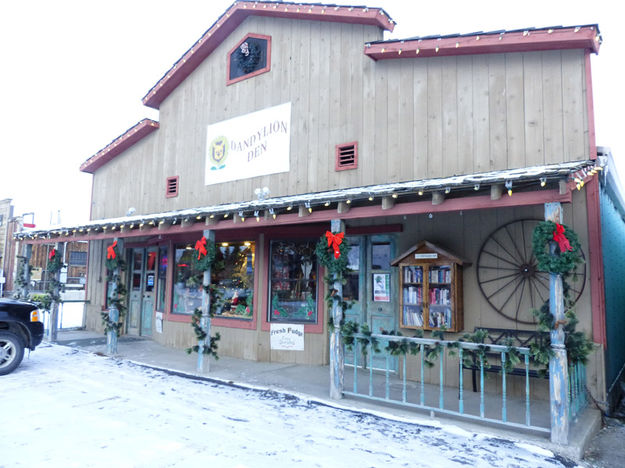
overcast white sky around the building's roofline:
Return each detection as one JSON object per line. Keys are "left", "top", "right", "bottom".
{"left": 0, "top": 0, "right": 625, "bottom": 227}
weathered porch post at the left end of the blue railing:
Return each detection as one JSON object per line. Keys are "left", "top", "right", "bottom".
{"left": 328, "top": 219, "right": 345, "bottom": 400}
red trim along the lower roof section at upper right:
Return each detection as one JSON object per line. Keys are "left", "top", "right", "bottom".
{"left": 365, "top": 26, "right": 601, "bottom": 60}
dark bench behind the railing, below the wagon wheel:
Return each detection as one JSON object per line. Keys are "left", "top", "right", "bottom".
{"left": 462, "top": 327, "right": 549, "bottom": 392}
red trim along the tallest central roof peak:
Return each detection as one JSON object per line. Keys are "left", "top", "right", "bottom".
{"left": 142, "top": 1, "right": 395, "bottom": 109}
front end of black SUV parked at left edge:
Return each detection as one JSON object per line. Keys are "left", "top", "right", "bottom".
{"left": 0, "top": 299, "right": 43, "bottom": 375}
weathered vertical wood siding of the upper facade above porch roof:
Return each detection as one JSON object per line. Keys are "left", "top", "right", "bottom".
{"left": 93, "top": 17, "right": 589, "bottom": 225}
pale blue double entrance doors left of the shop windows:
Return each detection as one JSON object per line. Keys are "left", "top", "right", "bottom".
{"left": 128, "top": 247, "right": 158, "bottom": 336}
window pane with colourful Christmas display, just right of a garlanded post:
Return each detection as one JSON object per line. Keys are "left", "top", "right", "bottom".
{"left": 211, "top": 242, "right": 255, "bottom": 320}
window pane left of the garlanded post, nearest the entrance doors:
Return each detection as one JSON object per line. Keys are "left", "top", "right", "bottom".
{"left": 172, "top": 245, "right": 204, "bottom": 314}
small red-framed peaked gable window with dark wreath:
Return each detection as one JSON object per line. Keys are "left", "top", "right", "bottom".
{"left": 227, "top": 34, "right": 271, "bottom": 85}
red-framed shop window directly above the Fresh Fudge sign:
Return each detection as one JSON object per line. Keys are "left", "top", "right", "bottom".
{"left": 269, "top": 241, "right": 317, "bottom": 323}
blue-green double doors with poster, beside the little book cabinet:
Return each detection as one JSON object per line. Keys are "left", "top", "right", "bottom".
{"left": 343, "top": 235, "right": 397, "bottom": 371}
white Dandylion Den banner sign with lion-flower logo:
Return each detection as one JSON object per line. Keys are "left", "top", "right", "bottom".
{"left": 205, "top": 102, "right": 291, "bottom": 185}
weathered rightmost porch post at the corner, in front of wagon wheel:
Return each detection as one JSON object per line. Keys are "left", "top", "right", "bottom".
{"left": 545, "top": 203, "right": 569, "bottom": 445}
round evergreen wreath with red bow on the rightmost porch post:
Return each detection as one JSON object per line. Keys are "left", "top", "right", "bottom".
{"left": 532, "top": 221, "right": 583, "bottom": 275}
